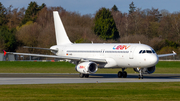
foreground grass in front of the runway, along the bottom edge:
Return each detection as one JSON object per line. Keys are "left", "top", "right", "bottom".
{"left": 0, "top": 82, "right": 180, "bottom": 101}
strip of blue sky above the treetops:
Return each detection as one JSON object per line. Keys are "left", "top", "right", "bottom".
{"left": 0, "top": 0, "right": 180, "bottom": 15}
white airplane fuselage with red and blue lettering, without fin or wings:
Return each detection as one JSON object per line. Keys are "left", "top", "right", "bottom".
{"left": 51, "top": 43, "right": 158, "bottom": 68}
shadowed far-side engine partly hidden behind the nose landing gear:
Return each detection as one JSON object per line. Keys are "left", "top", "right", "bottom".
{"left": 134, "top": 66, "right": 156, "bottom": 74}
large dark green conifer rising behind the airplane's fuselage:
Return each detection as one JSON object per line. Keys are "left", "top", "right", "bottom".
{"left": 94, "top": 8, "right": 119, "bottom": 40}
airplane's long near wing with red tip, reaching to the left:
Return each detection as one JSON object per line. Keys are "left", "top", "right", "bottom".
{"left": 7, "top": 52, "right": 107, "bottom": 63}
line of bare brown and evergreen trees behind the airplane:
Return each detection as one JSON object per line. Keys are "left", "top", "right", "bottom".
{"left": 0, "top": 2, "right": 180, "bottom": 54}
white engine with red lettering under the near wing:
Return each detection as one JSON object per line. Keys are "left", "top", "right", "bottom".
{"left": 75, "top": 62, "right": 98, "bottom": 74}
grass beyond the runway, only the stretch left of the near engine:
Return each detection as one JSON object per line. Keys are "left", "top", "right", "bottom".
{"left": 0, "top": 61, "right": 76, "bottom": 73}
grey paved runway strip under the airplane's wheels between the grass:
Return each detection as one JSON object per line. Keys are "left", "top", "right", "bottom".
{"left": 0, "top": 73, "right": 180, "bottom": 85}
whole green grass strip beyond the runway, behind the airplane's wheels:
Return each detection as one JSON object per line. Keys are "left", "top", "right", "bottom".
{"left": 0, "top": 61, "right": 180, "bottom": 73}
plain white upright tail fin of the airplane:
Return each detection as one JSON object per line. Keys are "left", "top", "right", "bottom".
{"left": 53, "top": 11, "right": 72, "bottom": 45}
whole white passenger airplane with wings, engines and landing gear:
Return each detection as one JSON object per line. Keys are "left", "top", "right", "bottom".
{"left": 7, "top": 11, "right": 176, "bottom": 79}
